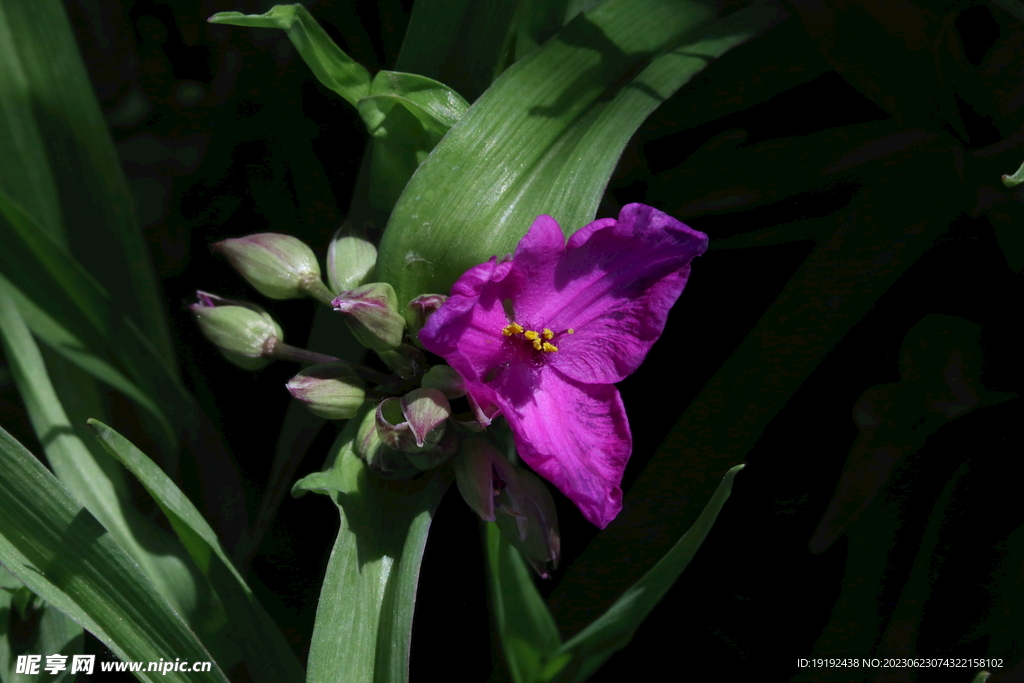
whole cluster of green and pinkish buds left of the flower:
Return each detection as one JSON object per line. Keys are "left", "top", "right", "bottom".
{"left": 191, "top": 230, "right": 559, "bottom": 577}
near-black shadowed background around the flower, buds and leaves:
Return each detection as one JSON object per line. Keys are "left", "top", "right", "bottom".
{"left": 5, "top": 0, "right": 1024, "bottom": 681}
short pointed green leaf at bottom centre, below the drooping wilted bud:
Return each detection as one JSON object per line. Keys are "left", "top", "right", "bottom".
{"left": 484, "top": 522, "right": 569, "bottom": 683}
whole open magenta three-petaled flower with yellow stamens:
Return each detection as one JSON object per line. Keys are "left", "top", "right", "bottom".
{"left": 420, "top": 204, "right": 708, "bottom": 528}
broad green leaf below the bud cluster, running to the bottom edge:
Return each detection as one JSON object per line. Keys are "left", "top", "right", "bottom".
{"left": 295, "top": 414, "right": 449, "bottom": 683}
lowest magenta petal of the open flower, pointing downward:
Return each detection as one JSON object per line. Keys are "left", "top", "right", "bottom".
{"left": 495, "top": 371, "right": 633, "bottom": 528}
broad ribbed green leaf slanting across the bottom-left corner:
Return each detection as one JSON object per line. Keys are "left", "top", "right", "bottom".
{"left": 0, "top": 428, "right": 227, "bottom": 683}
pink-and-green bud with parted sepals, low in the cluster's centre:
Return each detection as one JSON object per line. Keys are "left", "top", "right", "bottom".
{"left": 377, "top": 389, "right": 452, "bottom": 453}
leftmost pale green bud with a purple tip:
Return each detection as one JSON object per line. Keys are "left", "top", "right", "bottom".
{"left": 189, "top": 292, "right": 285, "bottom": 370}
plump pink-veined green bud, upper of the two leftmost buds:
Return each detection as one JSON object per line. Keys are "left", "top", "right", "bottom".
{"left": 213, "top": 232, "right": 331, "bottom": 301}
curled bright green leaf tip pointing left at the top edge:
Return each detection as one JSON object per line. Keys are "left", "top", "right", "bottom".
{"left": 209, "top": 5, "right": 370, "bottom": 106}
